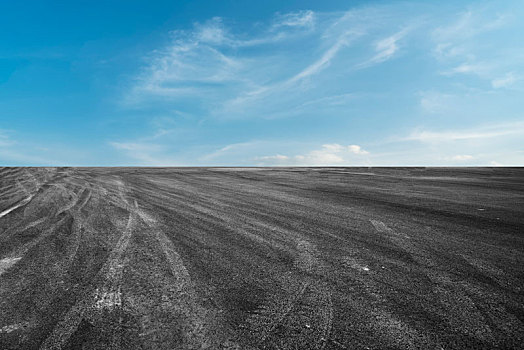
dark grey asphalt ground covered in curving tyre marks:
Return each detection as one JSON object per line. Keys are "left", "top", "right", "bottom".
{"left": 0, "top": 168, "right": 524, "bottom": 349}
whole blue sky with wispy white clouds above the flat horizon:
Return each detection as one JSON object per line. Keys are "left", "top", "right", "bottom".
{"left": 0, "top": 0, "right": 524, "bottom": 166}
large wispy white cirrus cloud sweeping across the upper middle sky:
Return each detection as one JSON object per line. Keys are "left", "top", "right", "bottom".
{"left": 125, "top": 9, "right": 409, "bottom": 119}
